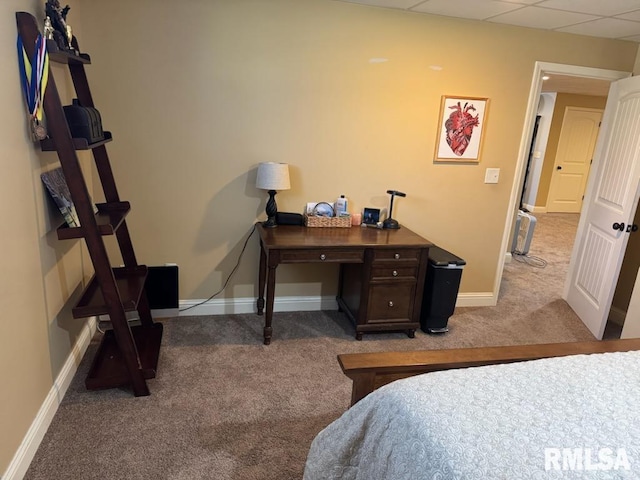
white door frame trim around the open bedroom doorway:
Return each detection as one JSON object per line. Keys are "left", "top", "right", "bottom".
{"left": 493, "top": 62, "right": 631, "bottom": 305}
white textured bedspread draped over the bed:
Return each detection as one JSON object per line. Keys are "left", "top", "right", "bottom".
{"left": 304, "top": 352, "right": 640, "bottom": 480}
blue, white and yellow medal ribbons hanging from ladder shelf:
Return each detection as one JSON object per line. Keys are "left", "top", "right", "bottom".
{"left": 17, "top": 34, "right": 49, "bottom": 140}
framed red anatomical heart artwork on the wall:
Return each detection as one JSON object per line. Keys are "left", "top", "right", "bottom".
{"left": 435, "top": 95, "right": 489, "bottom": 163}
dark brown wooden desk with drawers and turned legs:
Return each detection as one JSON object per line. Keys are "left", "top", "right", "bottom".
{"left": 257, "top": 223, "right": 432, "bottom": 345}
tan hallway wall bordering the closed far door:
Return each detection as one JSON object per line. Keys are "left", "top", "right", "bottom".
{"left": 535, "top": 93, "right": 607, "bottom": 207}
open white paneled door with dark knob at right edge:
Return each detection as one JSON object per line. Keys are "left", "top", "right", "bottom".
{"left": 564, "top": 77, "right": 640, "bottom": 339}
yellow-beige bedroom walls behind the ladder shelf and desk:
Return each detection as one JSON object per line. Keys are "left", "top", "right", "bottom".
{"left": 0, "top": 0, "right": 637, "bottom": 472}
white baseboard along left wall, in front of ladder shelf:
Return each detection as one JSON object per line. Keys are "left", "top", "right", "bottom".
{"left": 1, "top": 318, "right": 96, "bottom": 480}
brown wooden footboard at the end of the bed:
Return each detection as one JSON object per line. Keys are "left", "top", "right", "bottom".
{"left": 338, "top": 339, "right": 640, "bottom": 405}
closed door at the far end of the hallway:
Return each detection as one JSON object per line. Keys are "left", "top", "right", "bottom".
{"left": 547, "top": 107, "right": 602, "bottom": 213}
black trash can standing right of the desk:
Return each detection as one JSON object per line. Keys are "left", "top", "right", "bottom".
{"left": 420, "top": 246, "right": 467, "bottom": 333}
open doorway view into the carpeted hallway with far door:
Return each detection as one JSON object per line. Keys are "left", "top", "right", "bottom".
{"left": 516, "top": 87, "right": 610, "bottom": 288}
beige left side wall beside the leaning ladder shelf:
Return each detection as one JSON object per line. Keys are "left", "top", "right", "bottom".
{"left": 0, "top": 0, "right": 86, "bottom": 474}
